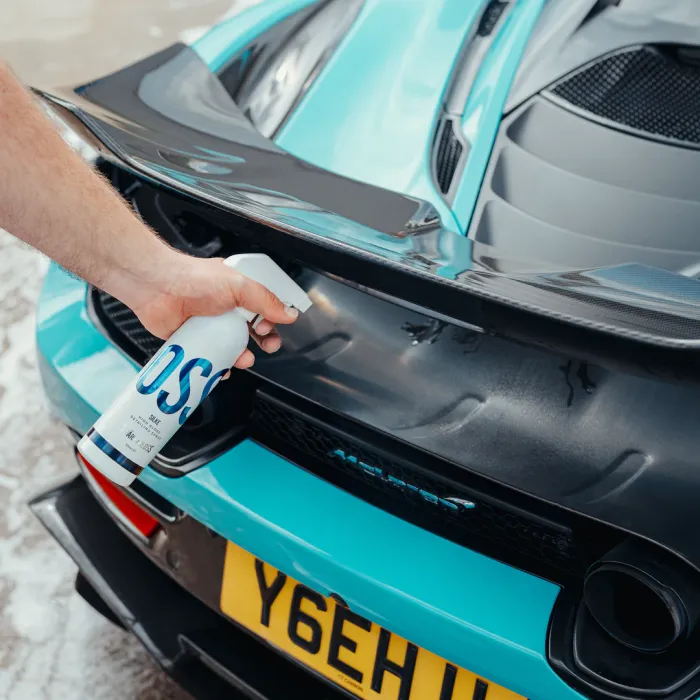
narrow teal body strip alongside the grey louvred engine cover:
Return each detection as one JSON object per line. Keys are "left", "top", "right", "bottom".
{"left": 452, "top": 0, "right": 546, "bottom": 231}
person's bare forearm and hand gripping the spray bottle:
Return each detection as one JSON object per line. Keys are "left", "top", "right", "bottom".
{"left": 0, "top": 62, "right": 296, "bottom": 367}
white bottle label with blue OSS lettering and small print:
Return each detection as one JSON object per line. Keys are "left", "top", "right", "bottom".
{"left": 90, "top": 343, "right": 229, "bottom": 472}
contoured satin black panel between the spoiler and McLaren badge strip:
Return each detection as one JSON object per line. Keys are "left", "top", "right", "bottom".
{"left": 78, "top": 168, "right": 700, "bottom": 584}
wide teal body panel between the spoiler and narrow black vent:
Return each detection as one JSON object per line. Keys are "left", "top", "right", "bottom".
{"left": 276, "top": 0, "right": 485, "bottom": 231}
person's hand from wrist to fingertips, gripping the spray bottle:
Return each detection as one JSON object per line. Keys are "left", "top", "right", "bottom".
{"left": 122, "top": 251, "right": 298, "bottom": 369}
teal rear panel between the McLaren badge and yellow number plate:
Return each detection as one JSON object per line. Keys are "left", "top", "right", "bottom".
{"left": 138, "top": 441, "right": 578, "bottom": 700}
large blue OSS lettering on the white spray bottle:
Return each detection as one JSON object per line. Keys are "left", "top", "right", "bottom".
{"left": 136, "top": 343, "right": 227, "bottom": 425}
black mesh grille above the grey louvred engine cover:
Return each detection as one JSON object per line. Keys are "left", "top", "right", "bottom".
{"left": 552, "top": 47, "right": 700, "bottom": 145}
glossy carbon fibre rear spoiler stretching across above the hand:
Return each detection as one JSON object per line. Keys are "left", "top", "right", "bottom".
{"left": 41, "top": 44, "right": 700, "bottom": 377}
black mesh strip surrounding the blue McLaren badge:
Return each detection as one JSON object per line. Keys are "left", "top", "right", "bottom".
{"left": 247, "top": 386, "right": 625, "bottom": 586}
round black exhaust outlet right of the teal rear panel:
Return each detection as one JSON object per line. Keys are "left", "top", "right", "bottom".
{"left": 583, "top": 540, "right": 700, "bottom": 654}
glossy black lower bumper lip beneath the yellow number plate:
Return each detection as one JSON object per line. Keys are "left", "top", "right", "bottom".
{"left": 31, "top": 477, "right": 346, "bottom": 700}
